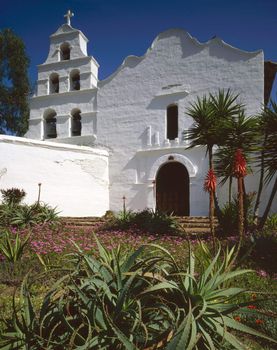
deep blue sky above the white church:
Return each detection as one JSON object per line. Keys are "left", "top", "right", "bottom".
{"left": 0, "top": 0, "right": 277, "bottom": 98}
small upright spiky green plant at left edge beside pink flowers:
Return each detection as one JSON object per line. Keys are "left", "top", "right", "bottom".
{"left": 0, "top": 231, "right": 30, "bottom": 262}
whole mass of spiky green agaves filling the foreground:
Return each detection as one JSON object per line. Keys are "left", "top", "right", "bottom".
{"left": 0, "top": 238, "right": 276, "bottom": 350}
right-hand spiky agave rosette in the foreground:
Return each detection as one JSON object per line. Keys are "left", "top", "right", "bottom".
{"left": 141, "top": 242, "right": 277, "bottom": 350}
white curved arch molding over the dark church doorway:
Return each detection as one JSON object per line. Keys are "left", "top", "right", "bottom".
{"left": 149, "top": 153, "right": 198, "bottom": 181}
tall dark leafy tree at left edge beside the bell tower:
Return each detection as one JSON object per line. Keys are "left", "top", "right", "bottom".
{"left": 0, "top": 29, "right": 30, "bottom": 136}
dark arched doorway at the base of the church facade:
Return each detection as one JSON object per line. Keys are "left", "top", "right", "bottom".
{"left": 156, "top": 162, "right": 189, "bottom": 216}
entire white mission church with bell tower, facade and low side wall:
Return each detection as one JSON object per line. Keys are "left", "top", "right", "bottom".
{"left": 0, "top": 12, "right": 277, "bottom": 216}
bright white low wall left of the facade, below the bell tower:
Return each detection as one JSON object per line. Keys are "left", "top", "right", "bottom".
{"left": 0, "top": 135, "right": 109, "bottom": 216}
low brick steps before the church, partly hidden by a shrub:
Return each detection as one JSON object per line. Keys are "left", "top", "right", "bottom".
{"left": 61, "top": 216, "right": 218, "bottom": 235}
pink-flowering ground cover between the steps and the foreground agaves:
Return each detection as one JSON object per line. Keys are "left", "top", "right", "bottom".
{"left": 0, "top": 223, "right": 277, "bottom": 349}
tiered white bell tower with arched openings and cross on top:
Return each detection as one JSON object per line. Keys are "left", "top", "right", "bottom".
{"left": 26, "top": 10, "right": 99, "bottom": 143}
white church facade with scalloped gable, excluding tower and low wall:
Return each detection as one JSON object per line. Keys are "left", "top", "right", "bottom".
{"left": 97, "top": 29, "right": 264, "bottom": 215}
